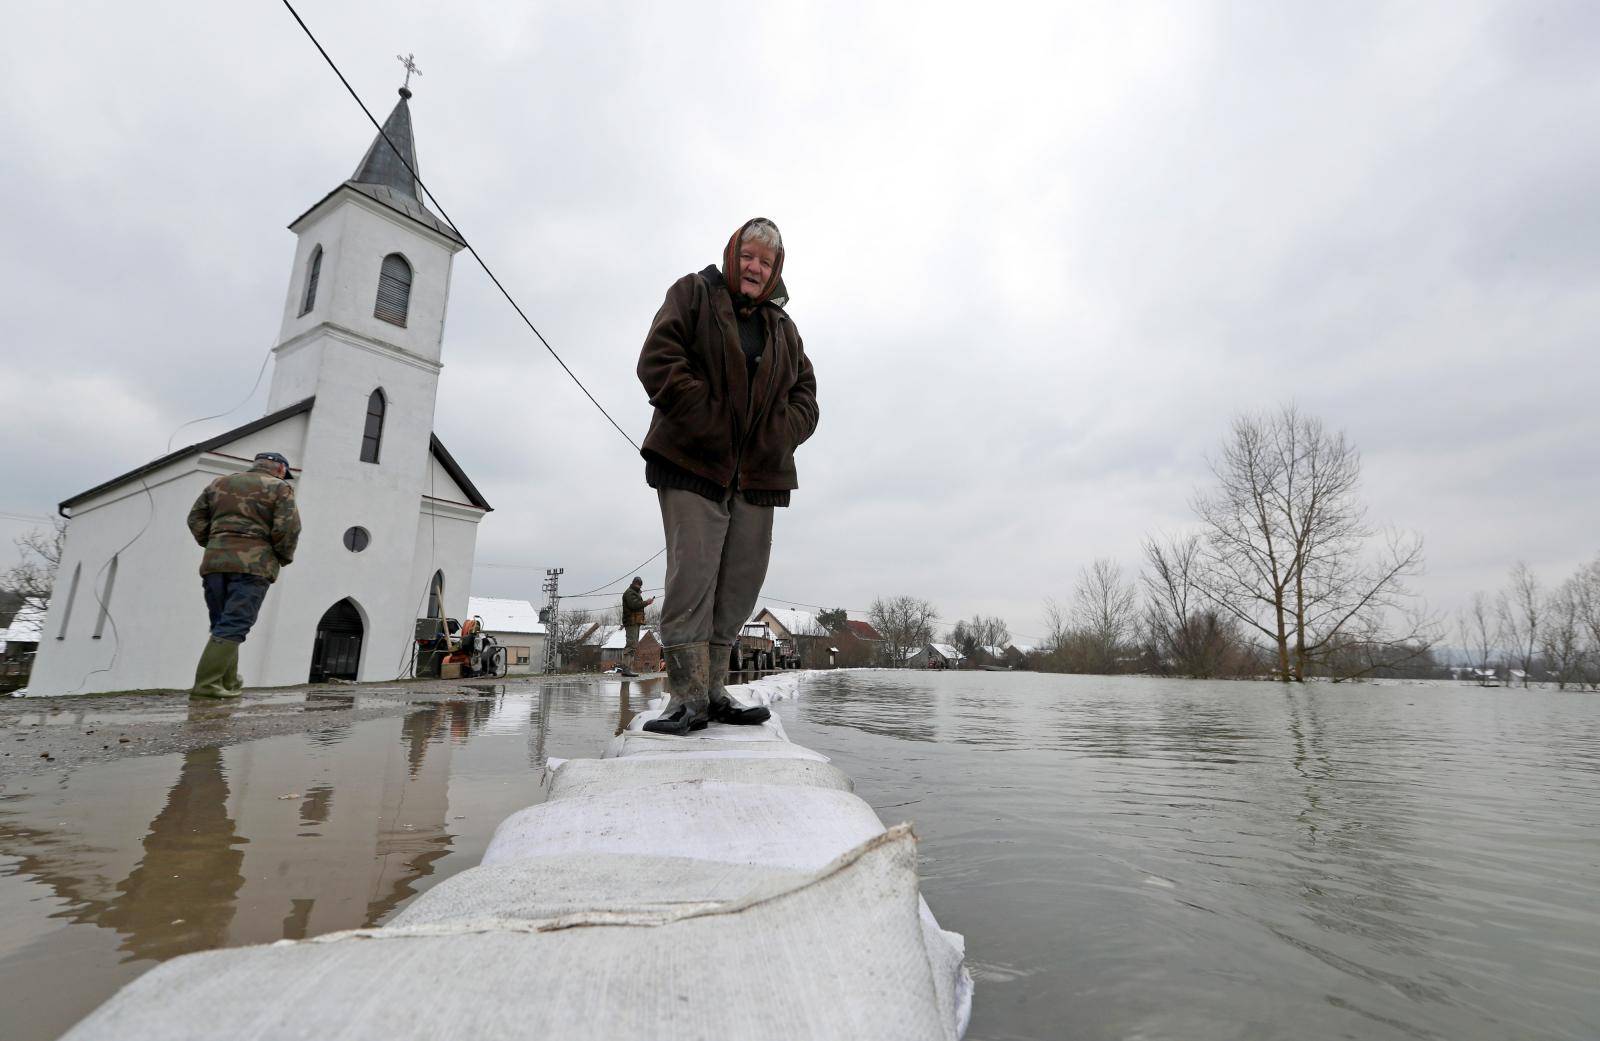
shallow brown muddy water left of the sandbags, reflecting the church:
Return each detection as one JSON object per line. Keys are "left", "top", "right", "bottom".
{"left": 0, "top": 680, "right": 659, "bottom": 1041}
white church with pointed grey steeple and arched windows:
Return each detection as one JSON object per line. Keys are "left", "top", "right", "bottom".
{"left": 29, "top": 88, "right": 490, "bottom": 696}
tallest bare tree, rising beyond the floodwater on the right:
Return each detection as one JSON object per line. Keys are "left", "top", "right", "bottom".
{"left": 1194, "top": 406, "right": 1432, "bottom": 683}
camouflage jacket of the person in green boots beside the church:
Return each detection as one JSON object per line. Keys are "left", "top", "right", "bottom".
{"left": 189, "top": 464, "right": 299, "bottom": 582}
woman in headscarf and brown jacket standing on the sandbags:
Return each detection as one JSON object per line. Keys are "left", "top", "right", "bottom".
{"left": 638, "top": 217, "right": 818, "bottom": 736}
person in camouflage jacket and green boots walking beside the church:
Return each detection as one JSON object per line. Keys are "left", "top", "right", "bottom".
{"left": 189, "top": 453, "right": 301, "bottom": 697}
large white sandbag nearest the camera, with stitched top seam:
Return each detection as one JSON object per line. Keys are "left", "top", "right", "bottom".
{"left": 66, "top": 827, "right": 957, "bottom": 1041}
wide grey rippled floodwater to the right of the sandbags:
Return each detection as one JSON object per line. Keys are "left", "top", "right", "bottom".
{"left": 784, "top": 673, "right": 1600, "bottom": 1041}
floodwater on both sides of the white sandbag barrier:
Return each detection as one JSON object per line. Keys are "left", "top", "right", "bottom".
{"left": 0, "top": 672, "right": 1600, "bottom": 1041}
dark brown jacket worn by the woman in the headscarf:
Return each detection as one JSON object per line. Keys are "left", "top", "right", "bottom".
{"left": 638, "top": 275, "right": 818, "bottom": 491}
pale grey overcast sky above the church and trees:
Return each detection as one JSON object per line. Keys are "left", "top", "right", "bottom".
{"left": 0, "top": 0, "right": 1600, "bottom": 636}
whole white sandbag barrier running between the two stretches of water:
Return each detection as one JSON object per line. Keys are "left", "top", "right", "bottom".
{"left": 66, "top": 673, "right": 971, "bottom": 1041}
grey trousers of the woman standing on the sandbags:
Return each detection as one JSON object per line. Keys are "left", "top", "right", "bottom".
{"left": 656, "top": 488, "right": 773, "bottom": 648}
